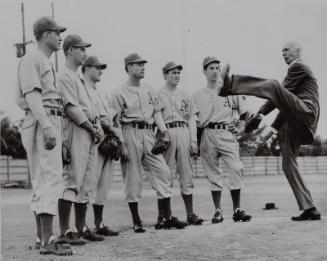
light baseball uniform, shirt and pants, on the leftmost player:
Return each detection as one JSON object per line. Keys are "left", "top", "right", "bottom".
{"left": 17, "top": 50, "right": 63, "bottom": 215}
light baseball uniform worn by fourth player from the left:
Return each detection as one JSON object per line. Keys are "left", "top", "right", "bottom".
{"left": 112, "top": 83, "right": 172, "bottom": 202}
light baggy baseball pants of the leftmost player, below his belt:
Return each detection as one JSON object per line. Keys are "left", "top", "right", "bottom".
{"left": 22, "top": 111, "right": 63, "bottom": 215}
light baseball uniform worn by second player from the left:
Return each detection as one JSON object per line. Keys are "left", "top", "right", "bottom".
{"left": 58, "top": 67, "right": 98, "bottom": 203}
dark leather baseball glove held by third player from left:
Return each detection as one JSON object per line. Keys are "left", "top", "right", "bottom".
{"left": 99, "top": 131, "right": 122, "bottom": 161}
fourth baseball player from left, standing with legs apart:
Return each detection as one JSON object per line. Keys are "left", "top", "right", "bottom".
{"left": 112, "top": 53, "right": 187, "bottom": 233}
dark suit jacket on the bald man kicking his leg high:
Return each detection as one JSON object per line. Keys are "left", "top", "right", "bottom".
{"left": 259, "top": 59, "right": 320, "bottom": 144}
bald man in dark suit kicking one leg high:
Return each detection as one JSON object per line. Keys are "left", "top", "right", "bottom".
{"left": 218, "top": 42, "right": 321, "bottom": 221}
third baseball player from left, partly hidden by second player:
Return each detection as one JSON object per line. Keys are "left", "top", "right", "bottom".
{"left": 82, "top": 56, "right": 122, "bottom": 236}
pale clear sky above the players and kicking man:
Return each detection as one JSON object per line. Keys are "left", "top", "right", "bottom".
{"left": 0, "top": 0, "right": 327, "bottom": 138}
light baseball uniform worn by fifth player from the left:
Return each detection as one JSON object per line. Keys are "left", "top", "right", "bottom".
{"left": 158, "top": 87, "right": 196, "bottom": 195}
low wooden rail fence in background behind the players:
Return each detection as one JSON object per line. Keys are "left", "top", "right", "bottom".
{"left": 0, "top": 156, "right": 327, "bottom": 184}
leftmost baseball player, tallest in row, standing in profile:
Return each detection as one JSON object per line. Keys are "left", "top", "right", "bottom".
{"left": 16, "top": 17, "right": 72, "bottom": 255}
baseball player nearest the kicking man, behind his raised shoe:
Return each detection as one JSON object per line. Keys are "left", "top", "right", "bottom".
{"left": 193, "top": 56, "right": 251, "bottom": 223}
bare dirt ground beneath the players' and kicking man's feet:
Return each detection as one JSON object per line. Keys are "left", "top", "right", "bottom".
{"left": 1, "top": 175, "right": 327, "bottom": 261}
